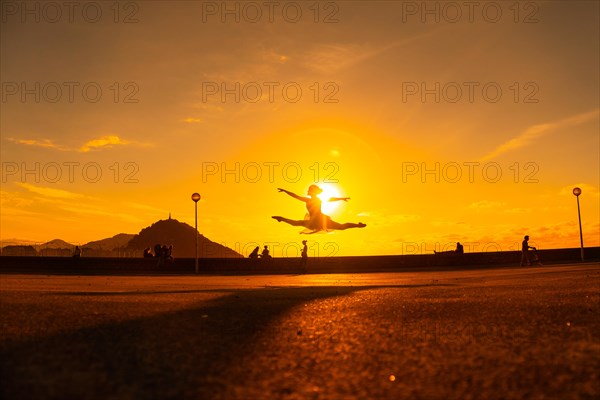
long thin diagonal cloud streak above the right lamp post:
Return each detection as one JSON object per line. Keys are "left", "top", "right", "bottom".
{"left": 480, "top": 109, "right": 600, "bottom": 161}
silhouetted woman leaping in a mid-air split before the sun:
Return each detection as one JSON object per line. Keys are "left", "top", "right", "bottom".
{"left": 272, "top": 185, "right": 367, "bottom": 233}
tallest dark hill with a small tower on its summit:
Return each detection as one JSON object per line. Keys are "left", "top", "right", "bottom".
{"left": 127, "top": 219, "right": 242, "bottom": 258}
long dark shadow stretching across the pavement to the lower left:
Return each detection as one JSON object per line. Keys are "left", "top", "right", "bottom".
{"left": 0, "top": 285, "right": 452, "bottom": 399}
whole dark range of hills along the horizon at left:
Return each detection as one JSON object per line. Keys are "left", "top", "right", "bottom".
{"left": 1, "top": 217, "right": 243, "bottom": 258}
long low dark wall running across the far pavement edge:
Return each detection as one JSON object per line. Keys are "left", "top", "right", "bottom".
{"left": 0, "top": 247, "right": 600, "bottom": 274}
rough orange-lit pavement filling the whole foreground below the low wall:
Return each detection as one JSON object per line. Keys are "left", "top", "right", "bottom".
{"left": 0, "top": 263, "right": 600, "bottom": 400}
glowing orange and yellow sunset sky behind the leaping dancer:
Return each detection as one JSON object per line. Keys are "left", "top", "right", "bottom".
{"left": 0, "top": 1, "right": 600, "bottom": 257}
